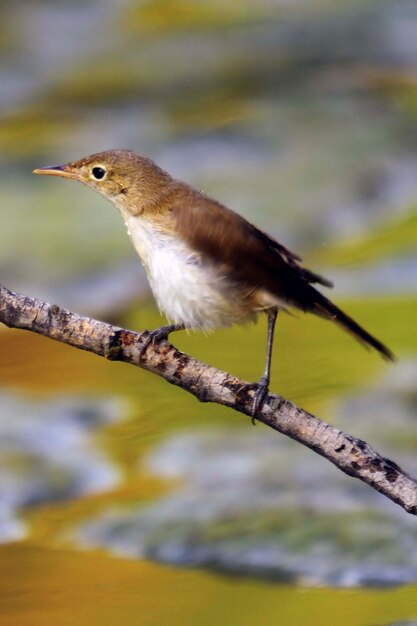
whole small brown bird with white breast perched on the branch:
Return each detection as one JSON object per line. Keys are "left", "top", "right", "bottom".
{"left": 34, "top": 150, "right": 394, "bottom": 416}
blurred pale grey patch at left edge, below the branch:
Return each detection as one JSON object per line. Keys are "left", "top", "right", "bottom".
{"left": 0, "top": 393, "right": 124, "bottom": 542}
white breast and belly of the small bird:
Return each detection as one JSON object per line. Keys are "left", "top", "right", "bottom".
{"left": 118, "top": 214, "right": 251, "bottom": 330}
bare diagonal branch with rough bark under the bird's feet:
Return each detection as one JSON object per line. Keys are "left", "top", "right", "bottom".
{"left": 0, "top": 285, "right": 417, "bottom": 515}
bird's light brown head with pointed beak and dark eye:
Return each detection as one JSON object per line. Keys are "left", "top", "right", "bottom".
{"left": 33, "top": 150, "right": 172, "bottom": 215}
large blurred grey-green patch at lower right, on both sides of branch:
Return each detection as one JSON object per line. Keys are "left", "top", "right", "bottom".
{"left": 77, "top": 361, "right": 417, "bottom": 586}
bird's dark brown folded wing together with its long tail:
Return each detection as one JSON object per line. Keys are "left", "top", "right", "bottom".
{"left": 170, "top": 187, "right": 394, "bottom": 360}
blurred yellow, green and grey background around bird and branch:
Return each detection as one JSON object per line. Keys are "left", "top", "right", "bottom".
{"left": 0, "top": 0, "right": 417, "bottom": 626}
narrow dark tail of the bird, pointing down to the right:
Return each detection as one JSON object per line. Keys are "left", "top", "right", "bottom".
{"left": 310, "top": 287, "right": 395, "bottom": 361}
